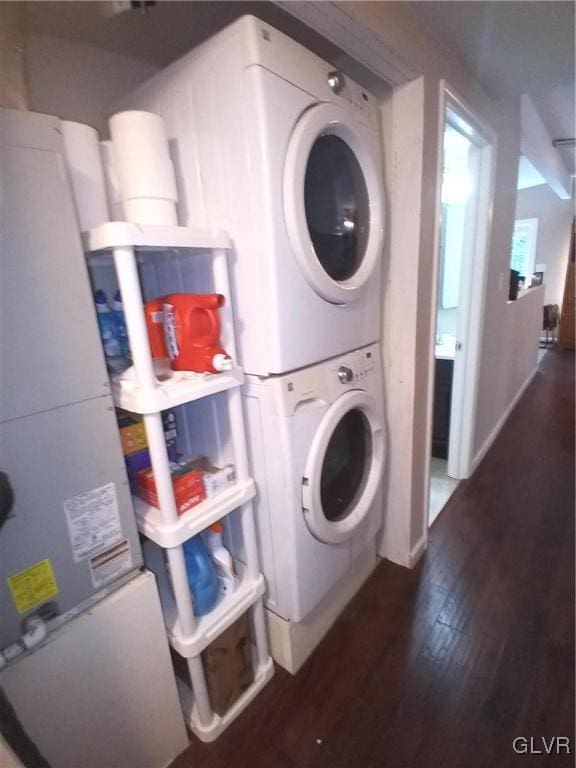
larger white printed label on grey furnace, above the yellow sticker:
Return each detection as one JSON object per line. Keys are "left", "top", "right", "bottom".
{"left": 64, "top": 483, "right": 122, "bottom": 563}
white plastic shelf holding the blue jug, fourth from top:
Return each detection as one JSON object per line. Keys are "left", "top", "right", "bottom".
{"left": 144, "top": 543, "right": 265, "bottom": 658}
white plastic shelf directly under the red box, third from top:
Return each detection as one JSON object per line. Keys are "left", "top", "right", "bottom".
{"left": 132, "top": 478, "right": 256, "bottom": 549}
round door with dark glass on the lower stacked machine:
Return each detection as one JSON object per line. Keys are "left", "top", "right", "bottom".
{"left": 302, "top": 390, "right": 384, "bottom": 544}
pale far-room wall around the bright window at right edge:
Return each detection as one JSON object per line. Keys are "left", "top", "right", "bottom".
{"left": 516, "top": 184, "right": 575, "bottom": 307}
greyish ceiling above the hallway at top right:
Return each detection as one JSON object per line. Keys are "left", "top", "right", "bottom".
{"left": 406, "top": 0, "right": 575, "bottom": 174}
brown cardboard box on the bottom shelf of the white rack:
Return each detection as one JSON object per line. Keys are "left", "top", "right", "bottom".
{"left": 202, "top": 614, "right": 254, "bottom": 715}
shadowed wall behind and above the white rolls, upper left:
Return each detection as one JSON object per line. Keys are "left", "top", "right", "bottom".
{"left": 25, "top": 35, "right": 157, "bottom": 137}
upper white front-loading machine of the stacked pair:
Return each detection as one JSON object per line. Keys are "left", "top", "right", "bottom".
{"left": 122, "top": 16, "right": 384, "bottom": 376}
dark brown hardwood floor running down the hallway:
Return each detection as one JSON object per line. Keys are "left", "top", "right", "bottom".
{"left": 173, "top": 351, "right": 575, "bottom": 768}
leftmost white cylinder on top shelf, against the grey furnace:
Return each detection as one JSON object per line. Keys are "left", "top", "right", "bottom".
{"left": 60, "top": 120, "right": 110, "bottom": 232}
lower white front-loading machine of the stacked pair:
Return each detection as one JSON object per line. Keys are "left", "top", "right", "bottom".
{"left": 244, "top": 344, "right": 385, "bottom": 621}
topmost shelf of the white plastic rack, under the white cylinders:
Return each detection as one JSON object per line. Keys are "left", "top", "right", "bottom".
{"left": 82, "top": 221, "right": 231, "bottom": 256}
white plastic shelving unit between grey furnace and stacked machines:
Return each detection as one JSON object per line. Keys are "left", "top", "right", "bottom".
{"left": 84, "top": 222, "right": 274, "bottom": 741}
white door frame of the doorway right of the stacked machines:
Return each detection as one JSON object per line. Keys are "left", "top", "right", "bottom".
{"left": 428, "top": 80, "right": 496, "bottom": 479}
